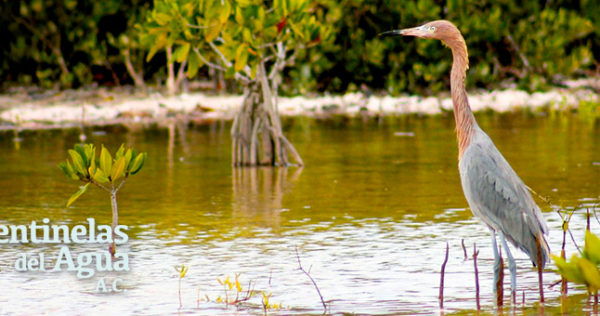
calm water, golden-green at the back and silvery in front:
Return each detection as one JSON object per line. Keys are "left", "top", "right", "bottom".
{"left": 0, "top": 114, "right": 600, "bottom": 315}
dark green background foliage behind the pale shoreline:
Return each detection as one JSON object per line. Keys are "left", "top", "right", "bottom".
{"left": 0, "top": 0, "right": 600, "bottom": 94}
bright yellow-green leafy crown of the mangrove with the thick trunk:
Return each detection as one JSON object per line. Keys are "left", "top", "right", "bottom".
{"left": 140, "top": 0, "right": 331, "bottom": 92}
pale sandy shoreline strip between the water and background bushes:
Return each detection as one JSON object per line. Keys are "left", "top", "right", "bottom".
{"left": 0, "top": 79, "right": 599, "bottom": 130}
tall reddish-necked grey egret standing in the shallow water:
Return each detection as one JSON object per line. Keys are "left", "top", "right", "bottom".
{"left": 381, "top": 20, "right": 550, "bottom": 300}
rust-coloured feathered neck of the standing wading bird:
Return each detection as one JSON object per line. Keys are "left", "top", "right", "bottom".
{"left": 443, "top": 32, "right": 477, "bottom": 160}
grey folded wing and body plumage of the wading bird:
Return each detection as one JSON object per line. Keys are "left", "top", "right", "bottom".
{"left": 459, "top": 130, "right": 548, "bottom": 263}
